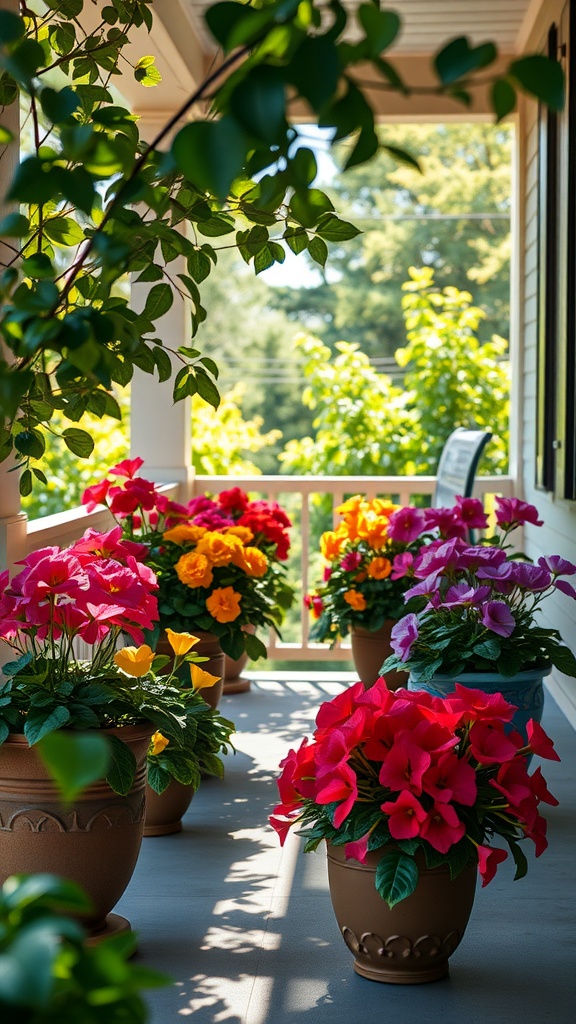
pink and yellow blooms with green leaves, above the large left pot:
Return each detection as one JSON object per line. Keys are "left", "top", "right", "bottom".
{"left": 0, "top": 526, "right": 234, "bottom": 793}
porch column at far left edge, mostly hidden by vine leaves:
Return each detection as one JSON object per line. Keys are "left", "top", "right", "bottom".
{"left": 0, "top": 0, "right": 27, "bottom": 571}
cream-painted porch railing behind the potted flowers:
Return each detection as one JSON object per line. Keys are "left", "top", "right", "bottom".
{"left": 28, "top": 476, "right": 512, "bottom": 662}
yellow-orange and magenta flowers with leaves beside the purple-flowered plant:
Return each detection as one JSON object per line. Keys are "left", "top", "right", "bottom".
{"left": 304, "top": 495, "right": 485, "bottom": 645}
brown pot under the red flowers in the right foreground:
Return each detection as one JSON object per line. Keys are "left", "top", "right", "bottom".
{"left": 327, "top": 845, "right": 478, "bottom": 985}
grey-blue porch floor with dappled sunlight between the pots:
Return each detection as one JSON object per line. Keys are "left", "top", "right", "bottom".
{"left": 117, "top": 672, "right": 576, "bottom": 1024}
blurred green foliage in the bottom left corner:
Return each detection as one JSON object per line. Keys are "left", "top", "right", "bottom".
{"left": 0, "top": 874, "right": 169, "bottom": 1024}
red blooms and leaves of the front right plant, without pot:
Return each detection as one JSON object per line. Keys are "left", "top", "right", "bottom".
{"left": 271, "top": 679, "right": 560, "bottom": 906}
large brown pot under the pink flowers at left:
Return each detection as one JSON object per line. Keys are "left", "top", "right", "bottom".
{"left": 0, "top": 722, "right": 154, "bottom": 937}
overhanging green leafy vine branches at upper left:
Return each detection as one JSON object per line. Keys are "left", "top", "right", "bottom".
{"left": 0, "top": 0, "right": 562, "bottom": 493}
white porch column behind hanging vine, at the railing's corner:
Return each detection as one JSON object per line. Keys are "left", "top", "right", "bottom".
{"left": 130, "top": 113, "right": 194, "bottom": 502}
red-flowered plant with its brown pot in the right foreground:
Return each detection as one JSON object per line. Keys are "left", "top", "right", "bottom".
{"left": 271, "top": 679, "right": 560, "bottom": 982}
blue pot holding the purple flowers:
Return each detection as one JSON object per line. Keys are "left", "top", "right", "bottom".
{"left": 408, "top": 669, "right": 551, "bottom": 739}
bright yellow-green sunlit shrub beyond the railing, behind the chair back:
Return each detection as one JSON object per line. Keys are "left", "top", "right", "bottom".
{"left": 280, "top": 268, "right": 509, "bottom": 476}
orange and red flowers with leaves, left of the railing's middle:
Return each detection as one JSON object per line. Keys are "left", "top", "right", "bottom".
{"left": 83, "top": 459, "right": 293, "bottom": 659}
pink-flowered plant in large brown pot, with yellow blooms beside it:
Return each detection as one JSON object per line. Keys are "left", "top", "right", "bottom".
{"left": 0, "top": 526, "right": 233, "bottom": 930}
